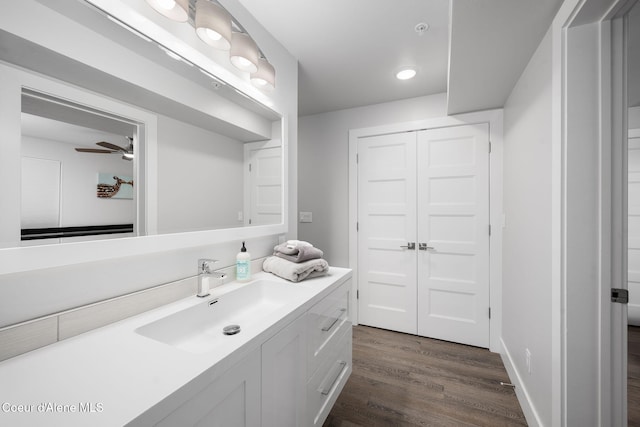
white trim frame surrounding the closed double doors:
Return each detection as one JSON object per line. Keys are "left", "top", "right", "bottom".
{"left": 349, "top": 109, "right": 504, "bottom": 353}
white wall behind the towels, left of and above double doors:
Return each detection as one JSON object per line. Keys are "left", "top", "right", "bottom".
{"left": 298, "top": 94, "right": 446, "bottom": 267}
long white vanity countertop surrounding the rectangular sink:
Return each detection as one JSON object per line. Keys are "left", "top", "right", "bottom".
{"left": 0, "top": 267, "right": 351, "bottom": 427}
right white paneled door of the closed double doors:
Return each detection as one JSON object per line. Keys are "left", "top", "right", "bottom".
{"left": 418, "top": 124, "right": 489, "bottom": 347}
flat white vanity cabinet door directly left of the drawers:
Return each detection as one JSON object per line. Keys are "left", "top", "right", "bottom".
{"left": 262, "top": 319, "right": 307, "bottom": 427}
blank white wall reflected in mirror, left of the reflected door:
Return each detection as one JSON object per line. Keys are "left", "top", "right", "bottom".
{"left": 158, "top": 116, "right": 244, "bottom": 234}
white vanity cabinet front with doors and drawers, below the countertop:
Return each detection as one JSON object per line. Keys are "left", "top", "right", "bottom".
{"left": 130, "top": 278, "right": 352, "bottom": 427}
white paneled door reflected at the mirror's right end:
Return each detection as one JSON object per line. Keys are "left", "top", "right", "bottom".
{"left": 244, "top": 140, "right": 282, "bottom": 225}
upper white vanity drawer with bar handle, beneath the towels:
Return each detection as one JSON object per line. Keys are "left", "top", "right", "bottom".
{"left": 307, "top": 280, "right": 351, "bottom": 378}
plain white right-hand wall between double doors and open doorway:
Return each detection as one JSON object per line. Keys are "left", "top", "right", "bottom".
{"left": 502, "top": 28, "right": 552, "bottom": 425}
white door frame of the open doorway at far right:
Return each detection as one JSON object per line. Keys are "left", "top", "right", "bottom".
{"left": 551, "top": 0, "right": 636, "bottom": 426}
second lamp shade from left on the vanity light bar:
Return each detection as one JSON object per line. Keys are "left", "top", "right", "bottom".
{"left": 195, "top": 0, "right": 231, "bottom": 50}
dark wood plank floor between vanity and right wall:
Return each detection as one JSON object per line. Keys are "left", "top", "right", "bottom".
{"left": 324, "top": 326, "right": 527, "bottom": 427}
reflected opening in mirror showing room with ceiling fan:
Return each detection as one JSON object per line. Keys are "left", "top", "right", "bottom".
{"left": 20, "top": 89, "right": 137, "bottom": 246}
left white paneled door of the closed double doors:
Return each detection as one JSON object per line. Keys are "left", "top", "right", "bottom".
{"left": 358, "top": 132, "right": 417, "bottom": 334}
